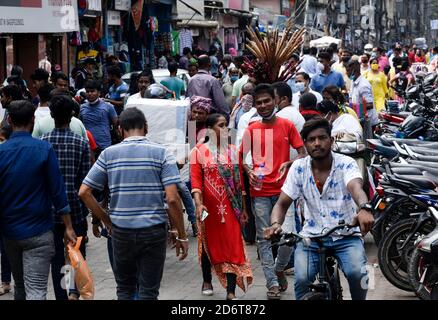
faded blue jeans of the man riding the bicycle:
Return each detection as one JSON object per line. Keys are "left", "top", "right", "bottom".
{"left": 295, "top": 237, "right": 368, "bottom": 300}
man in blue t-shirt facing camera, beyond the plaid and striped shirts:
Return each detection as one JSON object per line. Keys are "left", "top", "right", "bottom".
{"left": 79, "top": 81, "right": 117, "bottom": 158}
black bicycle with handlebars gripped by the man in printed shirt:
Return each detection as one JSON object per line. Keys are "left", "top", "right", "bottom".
{"left": 271, "top": 220, "right": 361, "bottom": 300}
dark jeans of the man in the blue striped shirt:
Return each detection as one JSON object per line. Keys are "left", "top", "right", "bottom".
{"left": 112, "top": 223, "right": 167, "bottom": 300}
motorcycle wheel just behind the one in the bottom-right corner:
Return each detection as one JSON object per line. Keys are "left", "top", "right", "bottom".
{"left": 378, "top": 219, "right": 434, "bottom": 292}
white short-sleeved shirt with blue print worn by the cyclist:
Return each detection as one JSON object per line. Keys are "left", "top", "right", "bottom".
{"left": 281, "top": 152, "right": 362, "bottom": 237}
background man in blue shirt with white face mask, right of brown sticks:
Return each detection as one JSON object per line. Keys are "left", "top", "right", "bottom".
{"left": 310, "top": 52, "right": 346, "bottom": 94}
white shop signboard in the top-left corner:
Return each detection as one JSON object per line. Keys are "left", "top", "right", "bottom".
{"left": 0, "top": 0, "right": 79, "bottom": 33}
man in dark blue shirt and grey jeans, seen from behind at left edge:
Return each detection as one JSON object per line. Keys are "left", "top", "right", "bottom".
{"left": 0, "top": 100, "right": 76, "bottom": 300}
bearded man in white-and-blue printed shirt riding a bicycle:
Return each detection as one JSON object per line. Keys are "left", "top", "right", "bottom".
{"left": 265, "top": 118, "right": 374, "bottom": 300}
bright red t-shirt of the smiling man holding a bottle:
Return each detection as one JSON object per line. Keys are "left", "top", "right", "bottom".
{"left": 240, "top": 117, "right": 304, "bottom": 197}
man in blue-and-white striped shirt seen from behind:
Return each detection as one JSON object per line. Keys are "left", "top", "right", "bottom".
{"left": 79, "top": 108, "right": 188, "bottom": 300}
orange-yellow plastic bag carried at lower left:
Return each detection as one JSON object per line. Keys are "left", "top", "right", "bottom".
{"left": 67, "top": 237, "right": 94, "bottom": 300}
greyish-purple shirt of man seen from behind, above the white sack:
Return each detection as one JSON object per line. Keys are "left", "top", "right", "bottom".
{"left": 187, "top": 70, "right": 230, "bottom": 119}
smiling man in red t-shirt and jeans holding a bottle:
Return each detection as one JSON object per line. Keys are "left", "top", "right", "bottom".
{"left": 240, "top": 84, "right": 306, "bottom": 299}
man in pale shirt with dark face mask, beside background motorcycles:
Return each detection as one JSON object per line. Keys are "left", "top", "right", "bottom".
{"left": 347, "top": 60, "right": 379, "bottom": 127}
